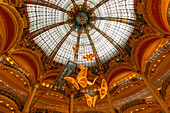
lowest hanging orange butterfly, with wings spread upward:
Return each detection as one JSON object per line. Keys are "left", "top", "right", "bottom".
{"left": 85, "top": 94, "right": 97, "bottom": 107}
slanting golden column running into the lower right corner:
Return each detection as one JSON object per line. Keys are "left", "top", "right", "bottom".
{"left": 140, "top": 74, "right": 170, "bottom": 113}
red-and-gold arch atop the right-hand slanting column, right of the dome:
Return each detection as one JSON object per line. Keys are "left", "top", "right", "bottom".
{"left": 131, "top": 35, "right": 169, "bottom": 72}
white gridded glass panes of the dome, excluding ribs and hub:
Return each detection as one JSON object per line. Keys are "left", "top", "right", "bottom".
{"left": 26, "top": 0, "right": 136, "bottom": 67}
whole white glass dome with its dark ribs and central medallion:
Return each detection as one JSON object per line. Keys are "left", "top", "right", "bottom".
{"left": 25, "top": 0, "right": 136, "bottom": 67}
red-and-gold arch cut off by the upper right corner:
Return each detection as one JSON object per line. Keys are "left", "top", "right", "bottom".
{"left": 141, "top": 0, "right": 170, "bottom": 34}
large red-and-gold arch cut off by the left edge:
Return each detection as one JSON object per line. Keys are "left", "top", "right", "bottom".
{"left": 0, "top": 3, "right": 24, "bottom": 55}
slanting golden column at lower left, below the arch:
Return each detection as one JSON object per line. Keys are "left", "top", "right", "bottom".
{"left": 22, "top": 84, "right": 39, "bottom": 113}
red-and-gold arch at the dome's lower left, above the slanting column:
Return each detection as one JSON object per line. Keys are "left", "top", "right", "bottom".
{"left": 9, "top": 48, "right": 43, "bottom": 83}
